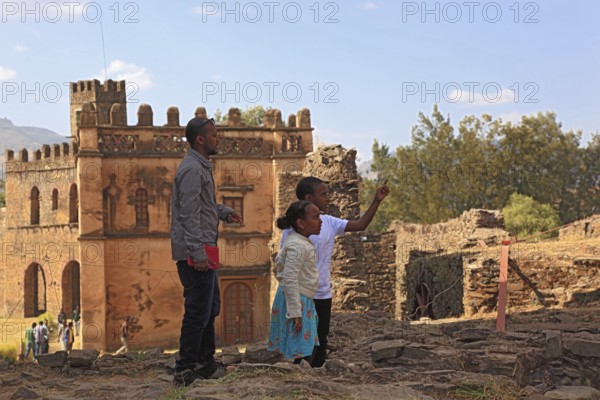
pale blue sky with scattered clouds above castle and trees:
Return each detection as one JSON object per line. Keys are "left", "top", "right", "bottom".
{"left": 0, "top": 0, "right": 600, "bottom": 161}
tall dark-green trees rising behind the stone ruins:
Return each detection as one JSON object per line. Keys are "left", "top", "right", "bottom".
{"left": 361, "top": 105, "right": 600, "bottom": 231}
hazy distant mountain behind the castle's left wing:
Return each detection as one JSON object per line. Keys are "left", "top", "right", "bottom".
{"left": 0, "top": 117, "right": 70, "bottom": 166}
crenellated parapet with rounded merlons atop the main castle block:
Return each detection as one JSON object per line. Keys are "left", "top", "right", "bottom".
{"left": 74, "top": 102, "right": 313, "bottom": 157}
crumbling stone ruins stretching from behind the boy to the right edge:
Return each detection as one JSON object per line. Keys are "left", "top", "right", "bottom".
{"left": 276, "top": 145, "right": 600, "bottom": 326}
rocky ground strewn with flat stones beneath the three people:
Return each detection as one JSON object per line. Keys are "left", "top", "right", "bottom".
{"left": 0, "top": 305, "right": 600, "bottom": 400}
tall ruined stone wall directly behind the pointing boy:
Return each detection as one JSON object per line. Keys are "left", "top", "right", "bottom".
{"left": 303, "top": 145, "right": 396, "bottom": 315}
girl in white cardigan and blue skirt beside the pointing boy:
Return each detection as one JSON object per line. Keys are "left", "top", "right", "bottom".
{"left": 268, "top": 200, "right": 321, "bottom": 362}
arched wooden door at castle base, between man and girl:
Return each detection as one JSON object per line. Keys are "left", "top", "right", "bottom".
{"left": 223, "top": 282, "right": 254, "bottom": 344}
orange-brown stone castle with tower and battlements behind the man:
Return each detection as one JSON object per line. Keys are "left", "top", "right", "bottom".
{"left": 0, "top": 80, "right": 313, "bottom": 349}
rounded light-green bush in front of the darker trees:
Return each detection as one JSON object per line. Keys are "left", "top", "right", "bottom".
{"left": 502, "top": 193, "right": 560, "bottom": 237}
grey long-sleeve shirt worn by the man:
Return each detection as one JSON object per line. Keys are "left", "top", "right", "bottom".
{"left": 171, "top": 149, "right": 234, "bottom": 261}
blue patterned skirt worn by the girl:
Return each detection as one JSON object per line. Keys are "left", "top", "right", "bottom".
{"left": 267, "top": 286, "right": 319, "bottom": 358}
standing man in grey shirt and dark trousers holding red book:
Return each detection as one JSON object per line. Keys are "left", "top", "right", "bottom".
{"left": 171, "top": 117, "right": 242, "bottom": 386}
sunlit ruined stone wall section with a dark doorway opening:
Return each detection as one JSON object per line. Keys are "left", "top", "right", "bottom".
{"left": 390, "top": 210, "right": 508, "bottom": 319}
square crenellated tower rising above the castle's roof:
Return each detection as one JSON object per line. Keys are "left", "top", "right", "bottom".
{"left": 70, "top": 79, "right": 127, "bottom": 136}
